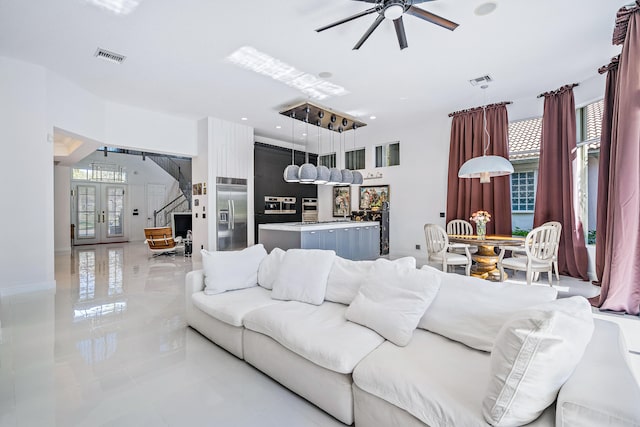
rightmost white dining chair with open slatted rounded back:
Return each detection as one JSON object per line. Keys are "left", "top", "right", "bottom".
{"left": 498, "top": 225, "right": 558, "bottom": 286}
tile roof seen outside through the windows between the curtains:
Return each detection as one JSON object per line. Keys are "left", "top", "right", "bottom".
{"left": 509, "top": 100, "right": 604, "bottom": 161}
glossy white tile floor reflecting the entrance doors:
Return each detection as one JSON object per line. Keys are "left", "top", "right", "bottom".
{"left": 0, "top": 243, "right": 640, "bottom": 427}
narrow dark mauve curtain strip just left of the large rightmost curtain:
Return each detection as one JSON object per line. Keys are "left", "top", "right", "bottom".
{"left": 595, "top": 57, "right": 619, "bottom": 284}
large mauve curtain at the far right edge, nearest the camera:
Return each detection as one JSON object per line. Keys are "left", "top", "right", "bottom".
{"left": 598, "top": 1, "right": 640, "bottom": 315}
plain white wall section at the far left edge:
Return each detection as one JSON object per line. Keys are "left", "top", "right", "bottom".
{"left": 0, "top": 57, "right": 55, "bottom": 295}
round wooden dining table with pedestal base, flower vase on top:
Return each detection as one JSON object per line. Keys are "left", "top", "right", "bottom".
{"left": 448, "top": 234, "right": 525, "bottom": 282}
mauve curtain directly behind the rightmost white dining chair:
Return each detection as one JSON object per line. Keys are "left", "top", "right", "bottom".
{"left": 533, "top": 85, "right": 588, "bottom": 280}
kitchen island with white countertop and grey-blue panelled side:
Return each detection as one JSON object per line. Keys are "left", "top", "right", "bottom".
{"left": 258, "top": 221, "right": 380, "bottom": 261}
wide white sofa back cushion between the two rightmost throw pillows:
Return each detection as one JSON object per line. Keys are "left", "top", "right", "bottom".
{"left": 418, "top": 266, "right": 558, "bottom": 351}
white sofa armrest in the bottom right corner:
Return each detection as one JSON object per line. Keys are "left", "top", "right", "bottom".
{"left": 556, "top": 319, "right": 640, "bottom": 427}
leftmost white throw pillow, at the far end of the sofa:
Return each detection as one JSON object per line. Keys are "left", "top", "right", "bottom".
{"left": 200, "top": 244, "right": 267, "bottom": 295}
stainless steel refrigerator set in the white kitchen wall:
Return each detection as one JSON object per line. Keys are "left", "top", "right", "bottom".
{"left": 216, "top": 177, "right": 247, "bottom": 251}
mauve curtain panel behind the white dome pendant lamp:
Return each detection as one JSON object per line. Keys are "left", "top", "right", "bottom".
{"left": 447, "top": 103, "right": 512, "bottom": 236}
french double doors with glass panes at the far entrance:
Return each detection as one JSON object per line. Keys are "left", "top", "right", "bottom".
{"left": 71, "top": 183, "right": 127, "bottom": 245}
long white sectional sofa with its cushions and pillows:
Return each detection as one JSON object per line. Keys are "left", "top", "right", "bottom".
{"left": 185, "top": 245, "right": 640, "bottom": 427}
